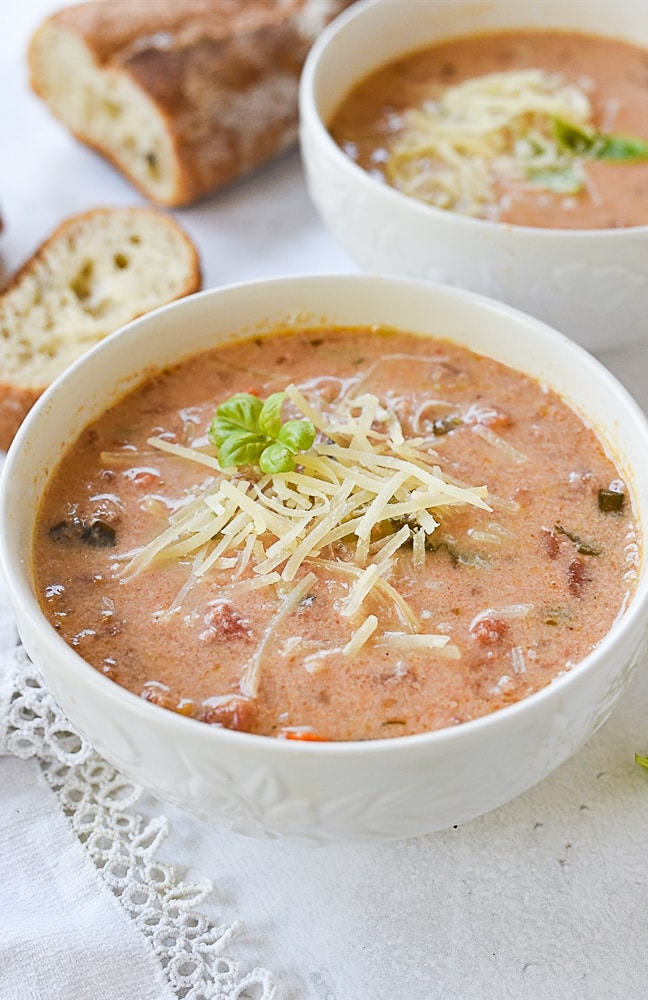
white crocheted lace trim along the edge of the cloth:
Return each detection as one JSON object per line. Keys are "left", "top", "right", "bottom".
{"left": 0, "top": 646, "right": 279, "bottom": 1000}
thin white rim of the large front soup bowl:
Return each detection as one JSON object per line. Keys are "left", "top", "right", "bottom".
{"left": 0, "top": 272, "right": 648, "bottom": 758}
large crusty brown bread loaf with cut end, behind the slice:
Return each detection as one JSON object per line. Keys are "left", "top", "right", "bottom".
{"left": 29, "top": 0, "right": 352, "bottom": 206}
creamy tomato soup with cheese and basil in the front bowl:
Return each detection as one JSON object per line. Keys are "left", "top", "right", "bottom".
{"left": 34, "top": 328, "right": 639, "bottom": 740}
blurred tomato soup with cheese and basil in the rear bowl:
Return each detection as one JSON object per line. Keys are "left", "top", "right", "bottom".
{"left": 330, "top": 31, "right": 648, "bottom": 229}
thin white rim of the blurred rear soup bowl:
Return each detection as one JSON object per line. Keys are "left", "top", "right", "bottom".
{"left": 299, "top": 0, "right": 648, "bottom": 243}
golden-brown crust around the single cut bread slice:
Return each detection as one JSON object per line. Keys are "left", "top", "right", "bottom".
{"left": 0, "top": 206, "right": 202, "bottom": 451}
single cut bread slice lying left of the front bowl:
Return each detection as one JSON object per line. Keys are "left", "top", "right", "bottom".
{"left": 0, "top": 208, "right": 201, "bottom": 448}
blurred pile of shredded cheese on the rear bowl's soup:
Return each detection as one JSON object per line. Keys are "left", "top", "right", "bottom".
{"left": 385, "top": 69, "right": 592, "bottom": 215}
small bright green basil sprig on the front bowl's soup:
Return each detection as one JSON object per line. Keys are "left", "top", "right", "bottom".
{"left": 208, "top": 392, "right": 315, "bottom": 474}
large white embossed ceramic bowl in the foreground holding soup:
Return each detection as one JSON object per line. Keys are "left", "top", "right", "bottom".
{"left": 0, "top": 275, "right": 648, "bottom": 843}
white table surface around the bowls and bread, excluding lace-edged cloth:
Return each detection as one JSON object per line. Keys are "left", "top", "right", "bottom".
{"left": 0, "top": 0, "right": 648, "bottom": 1000}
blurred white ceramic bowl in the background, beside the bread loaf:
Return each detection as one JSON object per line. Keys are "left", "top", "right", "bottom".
{"left": 300, "top": 0, "right": 648, "bottom": 351}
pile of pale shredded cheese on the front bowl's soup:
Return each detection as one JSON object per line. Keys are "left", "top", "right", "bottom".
{"left": 122, "top": 385, "right": 491, "bottom": 672}
